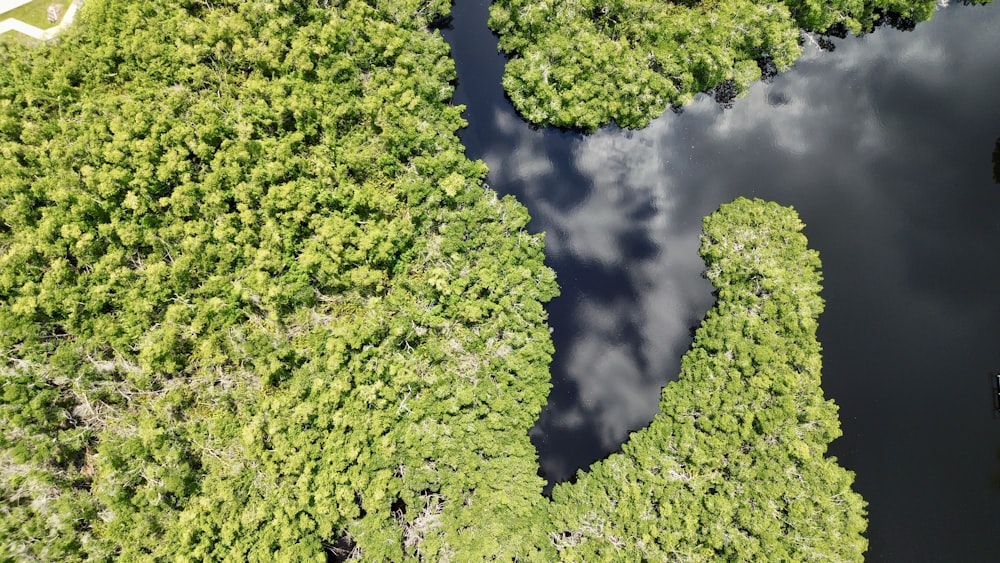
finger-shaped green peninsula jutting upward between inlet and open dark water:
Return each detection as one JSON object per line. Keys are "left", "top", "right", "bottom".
{"left": 552, "top": 199, "right": 867, "bottom": 561}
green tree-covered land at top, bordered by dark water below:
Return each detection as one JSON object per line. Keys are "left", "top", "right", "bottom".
{"left": 490, "top": 0, "right": 944, "bottom": 131}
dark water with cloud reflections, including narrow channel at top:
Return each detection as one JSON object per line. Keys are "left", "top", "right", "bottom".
{"left": 445, "top": 0, "right": 1000, "bottom": 561}
